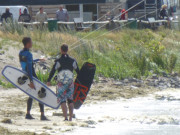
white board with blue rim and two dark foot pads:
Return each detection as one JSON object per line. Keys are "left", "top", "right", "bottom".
{"left": 2, "top": 66, "right": 60, "bottom": 109}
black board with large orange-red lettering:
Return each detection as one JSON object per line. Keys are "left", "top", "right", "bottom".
{"left": 73, "top": 62, "right": 96, "bottom": 109}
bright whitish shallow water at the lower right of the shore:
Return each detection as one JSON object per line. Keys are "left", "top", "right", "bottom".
{"left": 67, "top": 90, "right": 180, "bottom": 135}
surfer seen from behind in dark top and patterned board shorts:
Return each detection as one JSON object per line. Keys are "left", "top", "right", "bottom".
{"left": 47, "top": 44, "right": 79, "bottom": 121}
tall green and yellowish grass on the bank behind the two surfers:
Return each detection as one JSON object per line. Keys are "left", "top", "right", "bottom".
{"left": 0, "top": 21, "right": 180, "bottom": 82}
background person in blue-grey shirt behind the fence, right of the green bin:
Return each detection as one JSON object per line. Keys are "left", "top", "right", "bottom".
{"left": 56, "top": 5, "right": 69, "bottom": 22}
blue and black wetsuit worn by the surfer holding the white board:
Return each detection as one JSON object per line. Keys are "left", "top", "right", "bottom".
{"left": 19, "top": 48, "right": 44, "bottom": 112}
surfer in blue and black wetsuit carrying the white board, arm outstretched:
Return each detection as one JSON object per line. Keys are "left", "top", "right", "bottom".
{"left": 19, "top": 37, "right": 48, "bottom": 120}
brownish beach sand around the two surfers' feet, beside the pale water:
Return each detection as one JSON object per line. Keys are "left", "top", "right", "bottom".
{"left": 0, "top": 80, "right": 160, "bottom": 135}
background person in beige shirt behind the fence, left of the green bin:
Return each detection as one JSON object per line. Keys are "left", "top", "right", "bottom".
{"left": 35, "top": 7, "right": 47, "bottom": 24}
